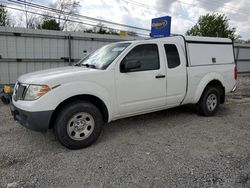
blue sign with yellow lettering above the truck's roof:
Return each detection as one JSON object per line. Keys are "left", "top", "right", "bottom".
{"left": 150, "top": 16, "right": 171, "bottom": 38}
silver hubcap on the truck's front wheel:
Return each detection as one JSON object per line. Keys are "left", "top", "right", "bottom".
{"left": 67, "top": 112, "right": 95, "bottom": 141}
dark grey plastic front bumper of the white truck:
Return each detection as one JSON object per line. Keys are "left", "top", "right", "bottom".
{"left": 10, "top": 103, "right": 53, "bottom": 132}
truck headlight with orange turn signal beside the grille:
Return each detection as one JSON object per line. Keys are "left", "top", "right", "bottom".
{"left": 24, "top": 85, "right": 50, "bottom": 101}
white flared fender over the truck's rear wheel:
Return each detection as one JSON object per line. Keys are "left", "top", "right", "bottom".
{"left": 193, "top": 72, "right": 225, "bottom": 103}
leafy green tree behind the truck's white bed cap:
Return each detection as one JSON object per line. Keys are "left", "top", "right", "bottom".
{"left": 186, "top": 14, "right": 240, "bottom": 41}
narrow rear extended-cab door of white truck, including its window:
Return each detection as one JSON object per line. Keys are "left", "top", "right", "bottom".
{"left": 163, "top": 44, "right": 187, "bottom": 107}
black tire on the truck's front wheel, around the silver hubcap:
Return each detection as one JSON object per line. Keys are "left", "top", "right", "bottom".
{"left": 54, "top": 101, "right": 104, "bottom": 149}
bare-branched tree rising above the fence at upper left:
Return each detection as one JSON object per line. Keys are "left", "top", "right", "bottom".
{"left": 51, "top": 0, "right": 80, "bottom": 30}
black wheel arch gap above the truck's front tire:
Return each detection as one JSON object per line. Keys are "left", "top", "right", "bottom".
{"left": 49, "top": 94, "right": 109, "bottom": 129}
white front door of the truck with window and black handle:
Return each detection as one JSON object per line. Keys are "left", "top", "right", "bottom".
{"left": 115, "top": 43, "right": 166, "bottom": 116}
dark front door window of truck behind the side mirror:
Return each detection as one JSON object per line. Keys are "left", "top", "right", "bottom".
{"left": 121, "top": 44, "right": 160, "bottom": 71}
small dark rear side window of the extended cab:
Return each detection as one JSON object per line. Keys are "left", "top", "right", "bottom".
{"left": 164, "top": 44, "right": 181, "bottom": 69}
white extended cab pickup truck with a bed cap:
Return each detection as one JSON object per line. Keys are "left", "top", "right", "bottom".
{"left": 11, "top": 36, "right": 237, "bottom": 149}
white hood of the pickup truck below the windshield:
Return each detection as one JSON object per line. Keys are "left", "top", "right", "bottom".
{"left": 18, "top": 66, "right": 102, "bottom": 85}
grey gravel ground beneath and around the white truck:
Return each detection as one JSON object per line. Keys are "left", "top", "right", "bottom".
{"left": 0, "top": 76, "right": 250, "bottom": 188}
